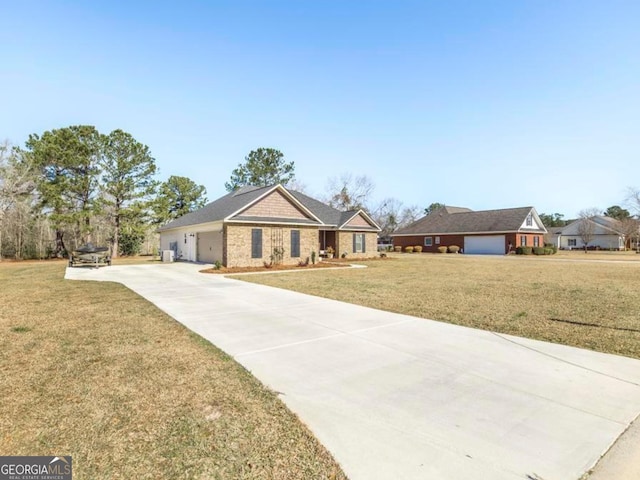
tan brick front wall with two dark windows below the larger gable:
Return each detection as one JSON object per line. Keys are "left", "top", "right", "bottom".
{"left": 223, "top": 225, "right": 319, "bottom": 267}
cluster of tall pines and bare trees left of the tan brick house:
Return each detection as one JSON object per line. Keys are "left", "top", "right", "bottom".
{"left": 0, "top": 125, "right": 206, "bottom": 259}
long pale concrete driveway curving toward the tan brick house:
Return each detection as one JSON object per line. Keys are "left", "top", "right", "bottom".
{"left": 66, "top": 263, "right": 640, "bottom": 480}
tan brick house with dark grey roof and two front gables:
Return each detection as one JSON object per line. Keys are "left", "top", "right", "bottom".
{"left": 158, "top": 185, "right": 380, "bottom": 267}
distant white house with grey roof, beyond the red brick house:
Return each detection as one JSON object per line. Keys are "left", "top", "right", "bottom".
{"left": 548, "top": 215, "right": 625, "bottom": 250}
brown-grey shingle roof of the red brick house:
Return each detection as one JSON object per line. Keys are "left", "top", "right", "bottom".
{"left": 391, "top": 207, "right": 542, "bottom": 236}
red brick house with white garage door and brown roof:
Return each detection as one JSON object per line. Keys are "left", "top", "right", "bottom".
{"left": 391, "top": 207, "right": 547, "bottom": 255}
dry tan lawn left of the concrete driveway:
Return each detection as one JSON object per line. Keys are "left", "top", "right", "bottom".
{"left": 0, "top": 259, "right": 345, "bottom": 480}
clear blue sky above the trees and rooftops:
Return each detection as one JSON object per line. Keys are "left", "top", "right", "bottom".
{"left": 0, "top": 0, "right": 640, "bottom": 217}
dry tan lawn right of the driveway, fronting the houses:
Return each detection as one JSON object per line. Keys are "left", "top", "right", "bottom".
{"left": 239, "top": 252, "right": 640, "bottom": 358}
